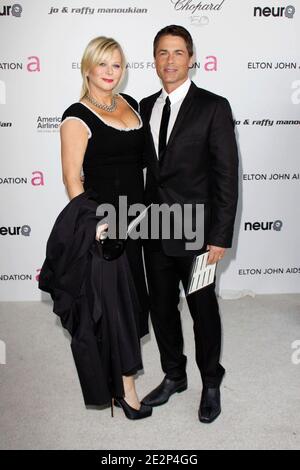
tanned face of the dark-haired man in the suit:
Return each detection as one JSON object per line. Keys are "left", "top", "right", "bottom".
{"left": 154, "top": 35, "right": 193, "bottom": 93}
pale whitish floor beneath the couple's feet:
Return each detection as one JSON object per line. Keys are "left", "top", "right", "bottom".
{"left": 0, "top": 295, "right": 300, "bottom": 450}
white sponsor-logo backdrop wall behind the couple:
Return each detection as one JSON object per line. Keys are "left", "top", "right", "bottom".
{"left": 0, "top": 0, "right": 300, "bottom": 300}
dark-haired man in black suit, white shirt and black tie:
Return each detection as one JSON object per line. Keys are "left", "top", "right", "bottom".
{"left": 140, "top": 25, "right": 238, "bottom": 423}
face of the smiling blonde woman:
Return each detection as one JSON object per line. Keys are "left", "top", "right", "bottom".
{"left": 87, "top": 49, "right": 123, "bottom": 93}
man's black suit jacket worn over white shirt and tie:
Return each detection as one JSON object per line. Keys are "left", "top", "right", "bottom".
{"left": 140, "top": 82, "right": 238, "bottom": 256}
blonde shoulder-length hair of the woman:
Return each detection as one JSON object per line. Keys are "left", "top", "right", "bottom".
{"left": 80, "top": 36, "right": 126, "bottom": 99}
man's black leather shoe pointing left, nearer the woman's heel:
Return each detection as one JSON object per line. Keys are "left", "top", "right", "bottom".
{"left": 142, "top": 376, "right": 187, "bottom": 406}
